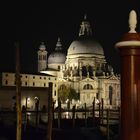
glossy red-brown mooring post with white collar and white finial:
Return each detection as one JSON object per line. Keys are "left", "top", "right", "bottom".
{"left": 116, "top": 11, "right": 140, "bottom": 140}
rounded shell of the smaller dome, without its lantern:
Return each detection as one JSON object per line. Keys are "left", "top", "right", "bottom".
{"left": 48, "top": 52, "right": 66, "bottom": 64}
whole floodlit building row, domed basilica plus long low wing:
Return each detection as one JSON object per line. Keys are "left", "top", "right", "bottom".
{"left": 0, "top": 16, "right": 120, "bottom": 110}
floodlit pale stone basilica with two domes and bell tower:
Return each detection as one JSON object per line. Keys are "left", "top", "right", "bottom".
{"left": 37, "top": 16, "right": 120, "bottom": 108}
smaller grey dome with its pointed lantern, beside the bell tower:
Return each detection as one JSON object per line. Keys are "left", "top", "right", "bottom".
{"left": 48, "top": 38, "right": 66, "bottom": 64}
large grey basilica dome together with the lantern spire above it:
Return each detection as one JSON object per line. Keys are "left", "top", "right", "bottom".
{"left": 67, "top": 15, "right": 104, "bottom": 55}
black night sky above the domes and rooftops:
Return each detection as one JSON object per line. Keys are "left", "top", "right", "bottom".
{"left": 0, "top": 0, "right": 140, "bottom": 73}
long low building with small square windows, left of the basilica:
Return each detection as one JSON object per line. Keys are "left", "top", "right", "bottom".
{"left": 0, "top": 72, "right": 57, "bottom": 110}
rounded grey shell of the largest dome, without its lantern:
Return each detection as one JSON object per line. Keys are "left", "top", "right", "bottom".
{"left": 67, "top": 37, "right": 104, "bottom": 55}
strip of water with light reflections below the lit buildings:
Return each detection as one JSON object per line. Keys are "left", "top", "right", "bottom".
{"left": 0, "top": 111, "right": 118, "bottom": 125}
